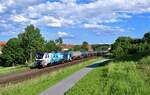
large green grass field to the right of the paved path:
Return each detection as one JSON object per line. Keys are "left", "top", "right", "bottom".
{"left": 65, "top": 58, "right": 150, "bottom": 95}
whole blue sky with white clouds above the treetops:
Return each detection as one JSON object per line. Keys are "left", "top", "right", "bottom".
{"left": 0, "top": 0, "right": 150, "bottom": 44}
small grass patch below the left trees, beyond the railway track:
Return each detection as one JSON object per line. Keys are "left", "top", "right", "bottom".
{"left": 0, "top": 65, "right": 30, "bottom": 76}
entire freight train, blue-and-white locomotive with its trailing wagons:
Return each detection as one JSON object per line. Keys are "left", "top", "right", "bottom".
{"left": 35, "top": 51, "right": 105, "bottom": 68}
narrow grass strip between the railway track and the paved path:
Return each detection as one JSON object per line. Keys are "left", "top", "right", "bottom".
{"left": 0, "top": 58, "right": 102, "bottom": 95}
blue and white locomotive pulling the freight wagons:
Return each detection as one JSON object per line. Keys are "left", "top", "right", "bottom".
{"left": 36, "top": 52, "right": 72, "bottom": 67}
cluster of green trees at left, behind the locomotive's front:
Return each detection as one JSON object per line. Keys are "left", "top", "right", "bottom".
{"left": 1, "top": 25, "right": 63, "bottom": 66}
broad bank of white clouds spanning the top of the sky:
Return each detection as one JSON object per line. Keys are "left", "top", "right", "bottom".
{"left": 0, "top": 0, "right": 150, "bottom": 36}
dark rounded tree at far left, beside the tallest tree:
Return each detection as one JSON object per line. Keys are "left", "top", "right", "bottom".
{"left": 2, "top": 38, "right": 25, "bottom": 66}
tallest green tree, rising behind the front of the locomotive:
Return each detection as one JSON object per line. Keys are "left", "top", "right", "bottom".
{"left": 18, "top": 25, "right": 45, "bottom": 62}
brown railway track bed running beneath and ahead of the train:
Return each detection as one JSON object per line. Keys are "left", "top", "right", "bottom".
{"left": 0, "top": 57, "right": 94, "bottom": 86}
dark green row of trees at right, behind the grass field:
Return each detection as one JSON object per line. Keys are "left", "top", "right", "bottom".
{"left": 111, "top": 32, "right": 150, "bottom": 57}
